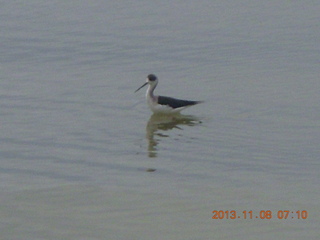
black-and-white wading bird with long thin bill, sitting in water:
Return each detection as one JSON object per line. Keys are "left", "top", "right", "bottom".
{"left": 135, "top": 74, "right": 203, "bottom": 114}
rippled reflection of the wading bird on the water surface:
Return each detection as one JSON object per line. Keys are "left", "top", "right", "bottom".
{"left": 146, "top": 114, "right": 201, "bottom": 158}
